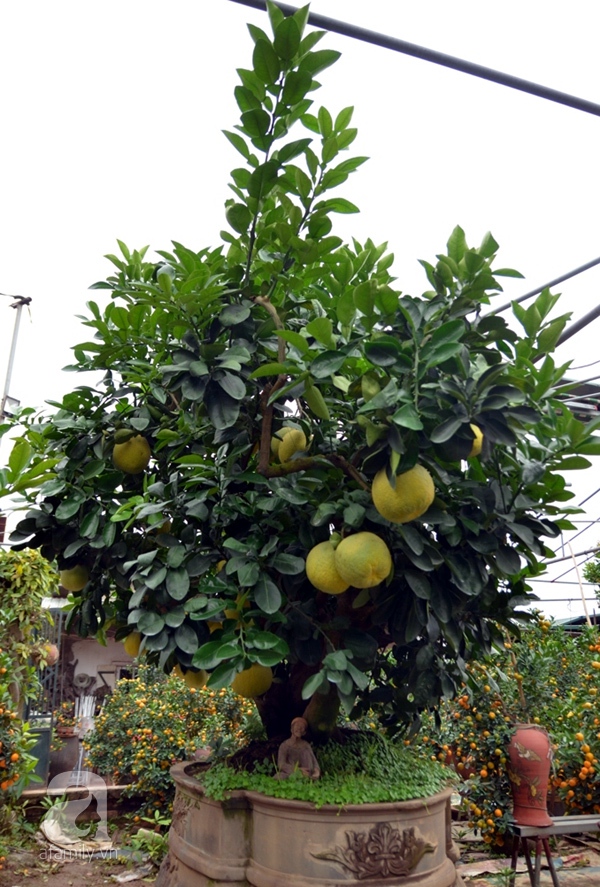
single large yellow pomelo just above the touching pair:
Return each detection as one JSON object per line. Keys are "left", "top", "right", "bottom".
{"left": 371, "top": 465, "right": 435, "bottom": 524}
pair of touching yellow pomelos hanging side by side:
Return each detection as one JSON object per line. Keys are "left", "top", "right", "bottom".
{"left": 306, "top": 531, "right": 392, "bottom": 594}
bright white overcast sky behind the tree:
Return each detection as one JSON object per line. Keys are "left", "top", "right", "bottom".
{"left": 0, "top": 0, "right": 600, "bottom": 616}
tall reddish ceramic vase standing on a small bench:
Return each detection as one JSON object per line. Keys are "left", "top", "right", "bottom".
{"left": 508, "top": 724, "right": 552, "bottom": 827}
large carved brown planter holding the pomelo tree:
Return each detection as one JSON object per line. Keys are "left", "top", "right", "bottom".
{"left": 156, "top": 762, "right": 462, "bottom": 887}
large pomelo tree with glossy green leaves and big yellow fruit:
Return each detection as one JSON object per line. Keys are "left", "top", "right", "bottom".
{"left": 8, "top": 4, "right": 600, "bottom": 738}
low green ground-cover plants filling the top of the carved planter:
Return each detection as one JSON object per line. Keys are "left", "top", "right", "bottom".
{"left": 201, "top": 733, "right": 453, "bottom": 807}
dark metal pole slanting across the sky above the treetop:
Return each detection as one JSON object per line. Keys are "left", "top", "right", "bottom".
{"left": 232, "top": 0, "right": 600, "bottom": 117}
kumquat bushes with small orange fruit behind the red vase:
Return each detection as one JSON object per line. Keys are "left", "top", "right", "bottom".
{"left": 413, "top": 615, "right": 600, "bottom": 846}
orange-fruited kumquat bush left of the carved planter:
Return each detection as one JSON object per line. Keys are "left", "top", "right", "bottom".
{"left": 85, "top": 665, "right": 254, "bottom": 810}
